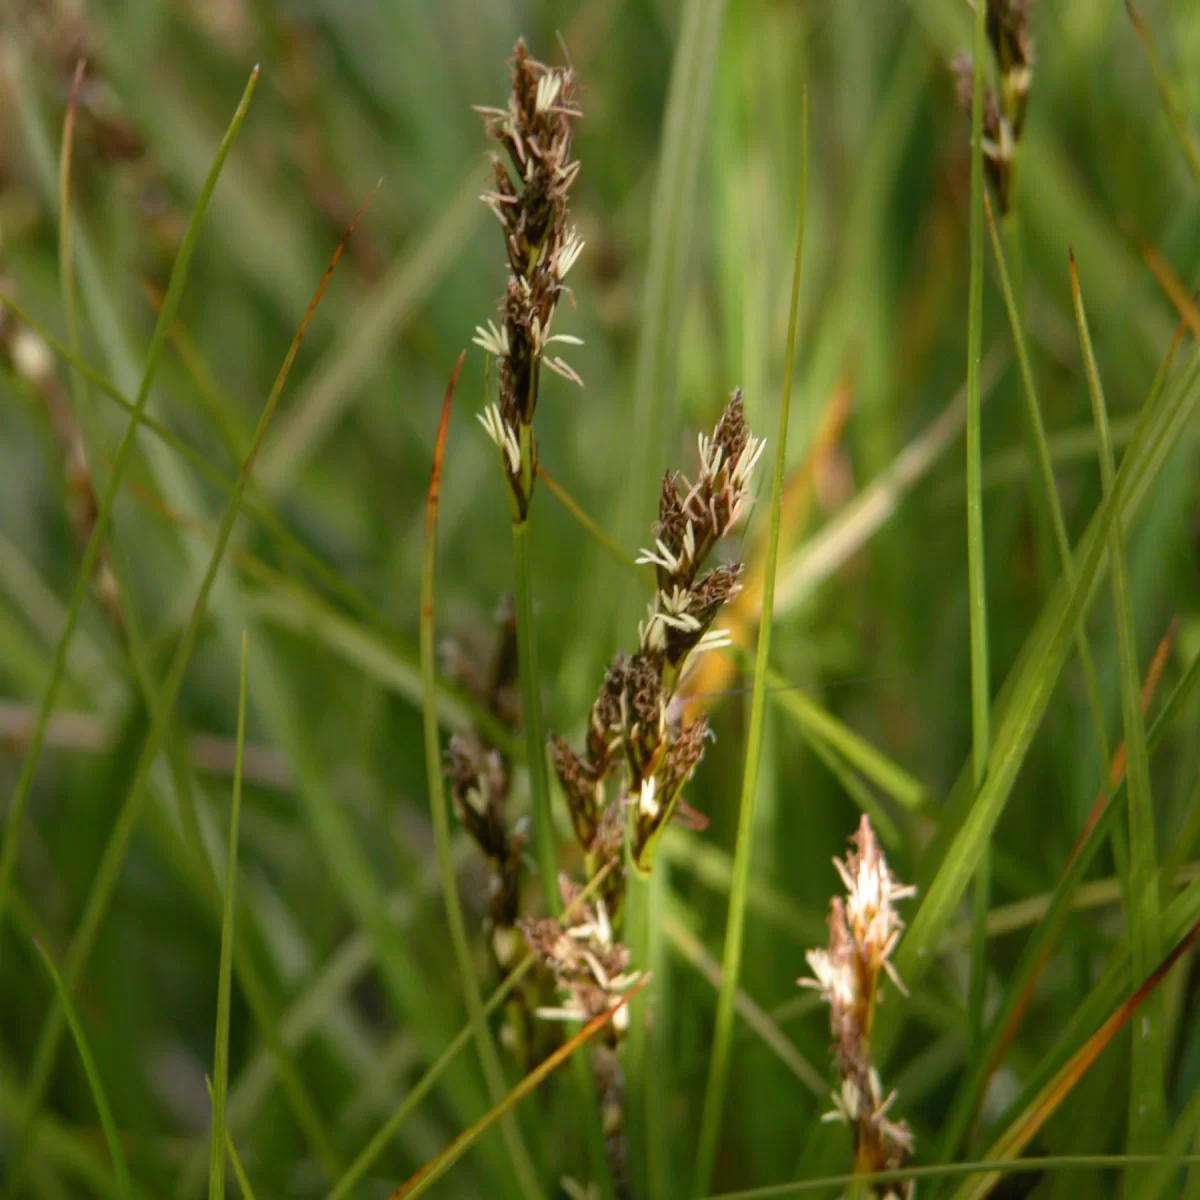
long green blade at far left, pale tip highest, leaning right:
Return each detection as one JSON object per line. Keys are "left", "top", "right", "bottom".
{"left": 0, "top": 67, "right": 258, "bottom": 936}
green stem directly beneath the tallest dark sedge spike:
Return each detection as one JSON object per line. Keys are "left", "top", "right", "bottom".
{"left": 512, "top": 521, "right": 563, "bottom": 913}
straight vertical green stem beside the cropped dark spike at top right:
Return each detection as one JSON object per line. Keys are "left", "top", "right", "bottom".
{"left": 966, "top": 4, "right": 991, "bottom": 1080}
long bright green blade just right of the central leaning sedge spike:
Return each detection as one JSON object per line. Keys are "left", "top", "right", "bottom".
{"left": 691, "top": 91, "right": 809, "bottom": 1196}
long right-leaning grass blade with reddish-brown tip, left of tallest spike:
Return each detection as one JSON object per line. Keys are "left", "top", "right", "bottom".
{"left": 13, "top": 166, "right": 373, "bottom": 1175}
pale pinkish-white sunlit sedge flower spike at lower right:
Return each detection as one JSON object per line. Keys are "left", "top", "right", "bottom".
{"left": 798, "top": 816, "right": 917, "bottom": 1200}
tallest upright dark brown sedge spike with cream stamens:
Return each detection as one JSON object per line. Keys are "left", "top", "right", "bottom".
{"left": 474, "top": 42, "right": 583, "bottom": 521}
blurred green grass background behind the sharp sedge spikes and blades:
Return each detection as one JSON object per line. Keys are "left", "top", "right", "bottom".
{"left": 0, "top": 0, "right": 1200, "bottom": 1196}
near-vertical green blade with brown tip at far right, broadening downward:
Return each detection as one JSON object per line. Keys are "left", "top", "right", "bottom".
{"left": 1070, "top": 254, "right": 1166, "bottom": 1154}
